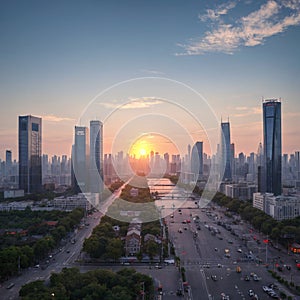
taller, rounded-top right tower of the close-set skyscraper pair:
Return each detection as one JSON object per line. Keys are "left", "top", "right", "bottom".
{"left": 90, "top": 120, "right": 103, "bottom": 193}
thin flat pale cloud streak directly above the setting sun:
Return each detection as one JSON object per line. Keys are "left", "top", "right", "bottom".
{"left": 99, "top": 97, "right": 164, "bottom": 109}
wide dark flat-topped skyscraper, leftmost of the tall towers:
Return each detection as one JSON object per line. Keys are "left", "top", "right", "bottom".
{"left": 19, "top": 116, "right": 42, "bottom": 193}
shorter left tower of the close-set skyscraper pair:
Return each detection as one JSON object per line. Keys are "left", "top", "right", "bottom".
{"left": 72, "top": 126, "right": 88, "bottom": 192}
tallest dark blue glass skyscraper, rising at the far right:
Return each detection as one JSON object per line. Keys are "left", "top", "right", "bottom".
{"left": 263, "top": 99, "right": 282, "bottom": 196}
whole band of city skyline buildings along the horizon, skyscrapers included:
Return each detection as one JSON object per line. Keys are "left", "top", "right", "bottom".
{"left": 0, "top": 99, "right": 300, "bottom": 219}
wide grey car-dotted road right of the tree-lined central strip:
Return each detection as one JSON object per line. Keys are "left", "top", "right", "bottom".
{"left": 166, "top": 197, "right": 298, "bottom": 299}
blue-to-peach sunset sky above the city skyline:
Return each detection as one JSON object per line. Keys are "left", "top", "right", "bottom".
{"left": 0, "top": 0, "right": 300, "bottom": 159}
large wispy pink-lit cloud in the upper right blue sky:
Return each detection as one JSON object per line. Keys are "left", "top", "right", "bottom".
{"left": 177, "top": 0, "right": 300, "bottom": 55}
